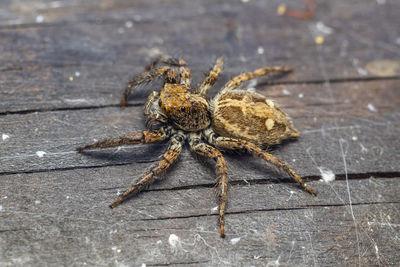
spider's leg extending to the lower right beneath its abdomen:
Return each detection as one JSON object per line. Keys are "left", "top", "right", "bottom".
{"left": 212, "top": 136, "right": 317, "bottom": 196}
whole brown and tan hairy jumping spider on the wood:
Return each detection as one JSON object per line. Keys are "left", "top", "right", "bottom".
{"left": 77, "top": 56, "right": 316, "bottom": 237}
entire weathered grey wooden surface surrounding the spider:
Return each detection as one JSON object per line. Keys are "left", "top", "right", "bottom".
{"left": 0, "top": 0, "right": 400, "bottom": 266}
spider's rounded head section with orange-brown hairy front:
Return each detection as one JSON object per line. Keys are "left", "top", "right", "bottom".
{"left": 160, "top": 83, "right": 211, "bottom": 132}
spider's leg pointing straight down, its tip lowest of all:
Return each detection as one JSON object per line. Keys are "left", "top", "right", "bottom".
{"left": 189, "top": 133, "right": 228, "bottom": 237}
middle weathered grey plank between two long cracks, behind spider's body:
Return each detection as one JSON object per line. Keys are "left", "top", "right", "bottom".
{"left": 0, "top": 81, "right": 400, "bottom": 177}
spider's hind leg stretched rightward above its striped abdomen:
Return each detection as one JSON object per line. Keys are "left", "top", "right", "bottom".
{"left": 220, "top": 66, "right": 292, "bottom": 94}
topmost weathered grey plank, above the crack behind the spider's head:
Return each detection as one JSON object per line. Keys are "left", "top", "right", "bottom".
{"left": 0, "top": 0, "right": 400, "bottom": 113}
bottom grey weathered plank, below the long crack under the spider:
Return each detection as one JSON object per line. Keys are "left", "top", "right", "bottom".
{"left": 0, "top": 172, "right": 400, "bottom": 266}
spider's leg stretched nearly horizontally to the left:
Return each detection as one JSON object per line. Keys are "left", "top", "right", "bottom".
{"left": 76, "top": 129, "right": 168, "bottom": 152}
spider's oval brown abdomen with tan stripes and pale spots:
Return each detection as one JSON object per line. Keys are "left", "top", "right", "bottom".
{"left": 212, "top": 90, "right": 299, "bottom": 147}
